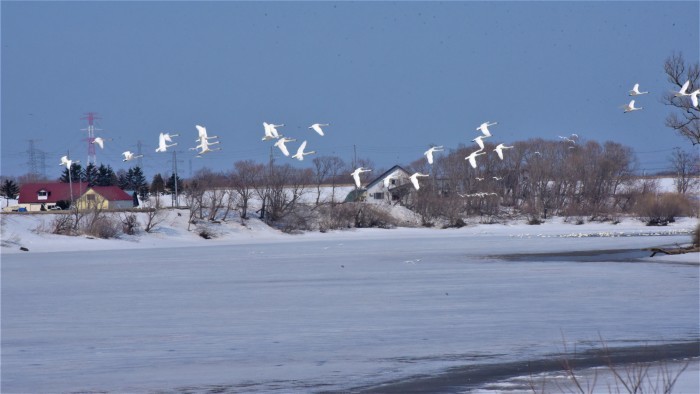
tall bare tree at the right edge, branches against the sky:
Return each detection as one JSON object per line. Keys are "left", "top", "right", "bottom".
{"left": 662, "top": 52, "right": 700, "bottom": 145}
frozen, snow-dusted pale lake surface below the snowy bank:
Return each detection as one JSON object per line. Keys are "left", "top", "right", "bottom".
{"left": 2, "top": 230, "right": 700, "bottom": 393}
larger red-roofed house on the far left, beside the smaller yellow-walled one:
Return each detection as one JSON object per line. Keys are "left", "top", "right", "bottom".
{"left": 17, "top": 182, "right": 88, "bottom": 212}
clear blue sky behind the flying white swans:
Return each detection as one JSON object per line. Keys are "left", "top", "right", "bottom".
{"left": 0, "top": 1, "right": 700, "bottom": 179}
